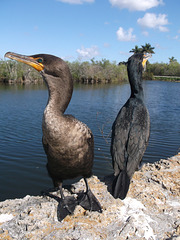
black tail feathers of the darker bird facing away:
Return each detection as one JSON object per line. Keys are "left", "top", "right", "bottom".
{"left": 112, "top": 171, "right": 130, "bottom": 200}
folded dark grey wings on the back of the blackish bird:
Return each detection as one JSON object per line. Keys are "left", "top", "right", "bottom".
{"left": 111, "top": 100, "right": 150, "bottom": 177}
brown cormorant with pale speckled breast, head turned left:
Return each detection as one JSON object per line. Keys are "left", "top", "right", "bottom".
{"left": 5, "top": 52, "right": 101, "bottom": 219}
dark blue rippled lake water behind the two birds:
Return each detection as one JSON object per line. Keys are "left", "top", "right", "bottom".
{"left": 0, "top": 81, "right": 180, "bottom": 201}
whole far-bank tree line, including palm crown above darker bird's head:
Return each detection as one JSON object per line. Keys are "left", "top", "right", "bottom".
{"left": 0, "top": 43, "right": 180, "bottom": 83}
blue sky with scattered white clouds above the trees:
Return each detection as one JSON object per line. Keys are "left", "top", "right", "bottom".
{"left": 0, "top": 0, "right": 180, "bottom": 62}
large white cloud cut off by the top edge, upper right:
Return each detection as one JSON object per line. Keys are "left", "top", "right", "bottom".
{"left": 109, "top": 0, "right": 163, "bottom": 11}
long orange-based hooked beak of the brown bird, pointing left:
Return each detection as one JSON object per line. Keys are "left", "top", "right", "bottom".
{"left": 4, "top": 52, "right": 44, "bottom": 72}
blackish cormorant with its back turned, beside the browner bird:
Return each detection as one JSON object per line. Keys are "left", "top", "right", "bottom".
{"left": 111, "top": 53, "right": 151, "bottom": 199}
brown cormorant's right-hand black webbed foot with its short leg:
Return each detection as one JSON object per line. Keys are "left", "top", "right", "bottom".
{"left": 78, "top": 179, "right": 102, "bottom": 213}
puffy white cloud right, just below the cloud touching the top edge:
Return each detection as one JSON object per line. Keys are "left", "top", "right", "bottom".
{"left": 137, "top": 13, "right": 169, "bottom": 32}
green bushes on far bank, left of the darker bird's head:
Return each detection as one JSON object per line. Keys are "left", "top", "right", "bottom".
{"left": 0, "top": 59, "right": 128, "bottom": 83}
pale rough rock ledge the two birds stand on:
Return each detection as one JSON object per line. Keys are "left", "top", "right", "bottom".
{"left": 0, "top": 153, "right": 180, "bottom": 240}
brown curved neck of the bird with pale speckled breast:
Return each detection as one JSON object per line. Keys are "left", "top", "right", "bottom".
{"left": 43, "top": 74, "right": 73, "bottom": 114}
